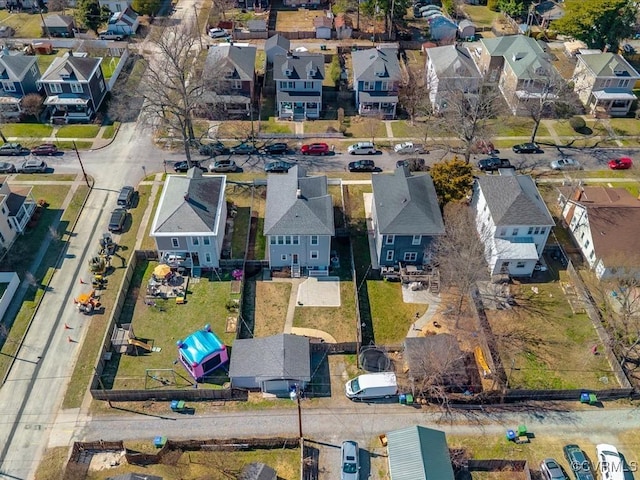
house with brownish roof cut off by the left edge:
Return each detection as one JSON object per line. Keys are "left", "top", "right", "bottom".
{"left": 0, "top": 177, "right": 36, "bottom": 250}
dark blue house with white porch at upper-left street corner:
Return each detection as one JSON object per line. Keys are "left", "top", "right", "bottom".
{"left": 38, "top": 51, "right": 107, "bottom": 123}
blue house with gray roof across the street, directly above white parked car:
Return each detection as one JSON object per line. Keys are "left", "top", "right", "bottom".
{"left": 351, "top": 45, "right": 402, "bottom": 119}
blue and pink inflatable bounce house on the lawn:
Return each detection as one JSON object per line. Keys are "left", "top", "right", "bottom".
{"left": 177, "top": 325, "right": 229, "bottom": 380}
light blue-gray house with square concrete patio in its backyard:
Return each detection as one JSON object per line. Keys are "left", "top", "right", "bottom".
{"left": 264, "top": 165, "right": 335, "bottom": 277}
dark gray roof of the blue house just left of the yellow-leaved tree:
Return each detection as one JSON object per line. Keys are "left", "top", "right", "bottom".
{"left": 371, "top": 167, "right": 444, "bottom": 235}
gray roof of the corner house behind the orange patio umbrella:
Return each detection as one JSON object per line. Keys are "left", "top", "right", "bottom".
{"left": 151, "top": 167, "right": 226, "bottom": 235}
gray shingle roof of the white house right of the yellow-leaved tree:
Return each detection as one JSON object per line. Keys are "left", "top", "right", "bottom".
{"left": 476, "top": 175, "right": 555, "bottom": 226}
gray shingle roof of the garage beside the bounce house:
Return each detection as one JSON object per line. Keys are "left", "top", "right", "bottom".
{"left": 229, "top": 333, "right": 311, "bottom": 382}
